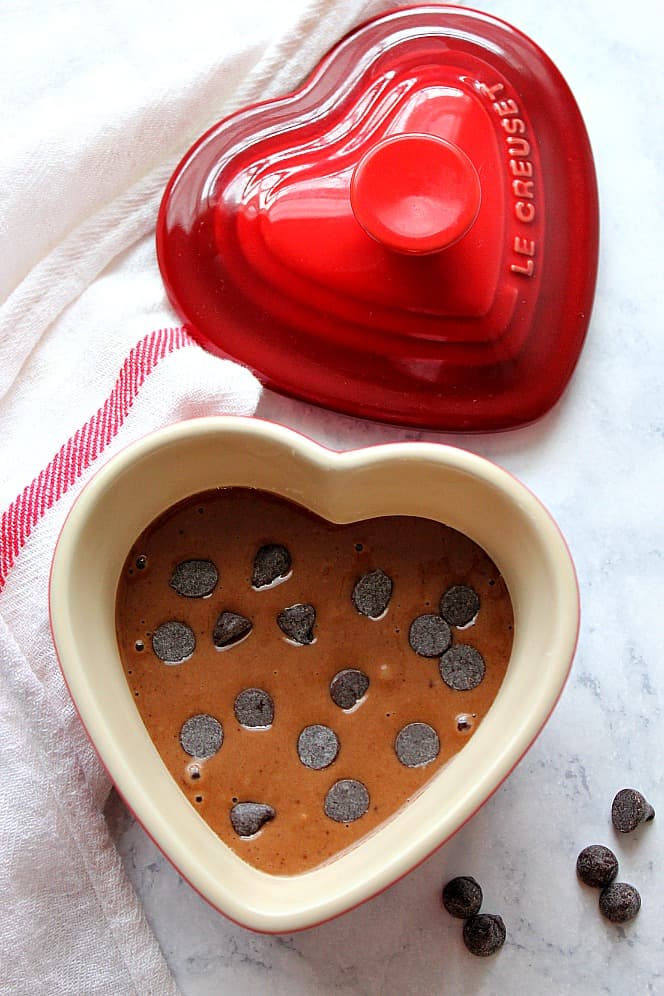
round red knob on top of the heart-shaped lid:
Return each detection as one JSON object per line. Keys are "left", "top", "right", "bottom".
{"left": 350, "top": 134, "right": 481, "bottom": 255}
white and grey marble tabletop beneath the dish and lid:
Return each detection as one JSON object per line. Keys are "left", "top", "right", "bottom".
{"left": 109, "top": 0, "right": 664, "bottom": 996}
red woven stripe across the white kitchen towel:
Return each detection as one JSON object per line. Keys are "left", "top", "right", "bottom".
{"left": 0, "top": 328, "right": 194, "bottom": 591}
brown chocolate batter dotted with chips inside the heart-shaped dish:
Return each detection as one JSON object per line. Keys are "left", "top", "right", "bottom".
{"left": 116, "top": 488, "right": 513, "bottom": 874}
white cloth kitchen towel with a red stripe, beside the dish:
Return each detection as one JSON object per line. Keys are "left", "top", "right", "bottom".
{"left": 0, "top": 0, "right": 380, "bottom": 996}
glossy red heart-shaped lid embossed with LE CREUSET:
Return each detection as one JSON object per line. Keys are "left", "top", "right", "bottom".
{"left": 157, "top": 6, "right": 598, "bottom": 431}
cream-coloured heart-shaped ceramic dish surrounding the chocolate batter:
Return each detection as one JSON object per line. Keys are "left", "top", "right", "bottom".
{"left": 50, "top": 416, "right": 579, "bottom": 933}
